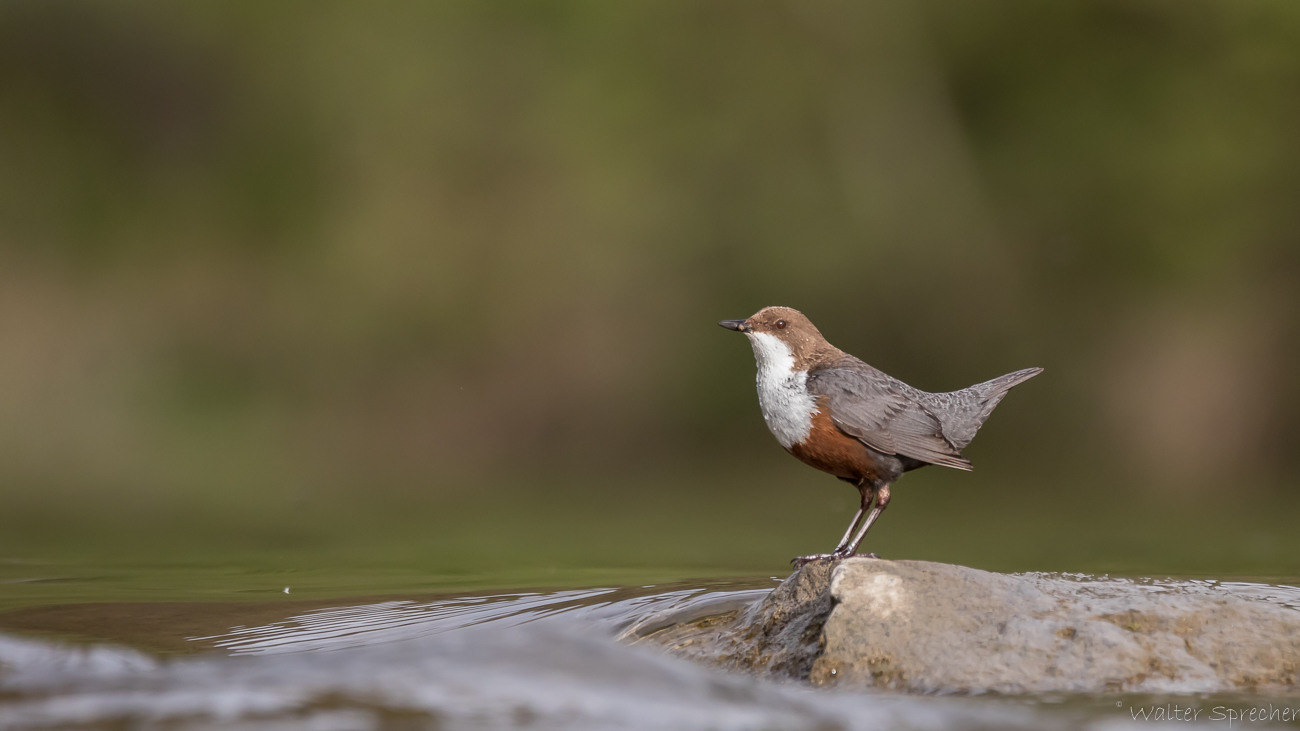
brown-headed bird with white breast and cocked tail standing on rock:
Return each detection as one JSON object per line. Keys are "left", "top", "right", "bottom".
{"left": 718, "top": 307, "right": 1043, "bottom": 567}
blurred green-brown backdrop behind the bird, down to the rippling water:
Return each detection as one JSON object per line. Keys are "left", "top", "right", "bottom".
{"left": 0, "top": 0, "right": 1300, "bottom": 596}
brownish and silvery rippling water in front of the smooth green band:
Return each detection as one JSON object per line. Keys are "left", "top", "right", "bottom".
{"left": 0, "top": 576, "right": 1300, "bottom": 731}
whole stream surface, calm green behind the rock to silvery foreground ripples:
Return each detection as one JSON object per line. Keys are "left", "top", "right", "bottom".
{"left": 0, "top": 466, "right": 1300, "bottom": 731}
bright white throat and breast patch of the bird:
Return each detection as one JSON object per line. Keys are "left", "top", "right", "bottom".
{"left": 745, "top": 333, "right": 818, "bottom": 449}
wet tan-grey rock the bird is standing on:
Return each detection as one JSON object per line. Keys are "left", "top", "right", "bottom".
{"left": 628, "top": 559, "right": 1300, "bottom": 693}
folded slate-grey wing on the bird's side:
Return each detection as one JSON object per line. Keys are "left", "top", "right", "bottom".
{"left": 807, "top": 363, "right": 971, "bottom": 470}
